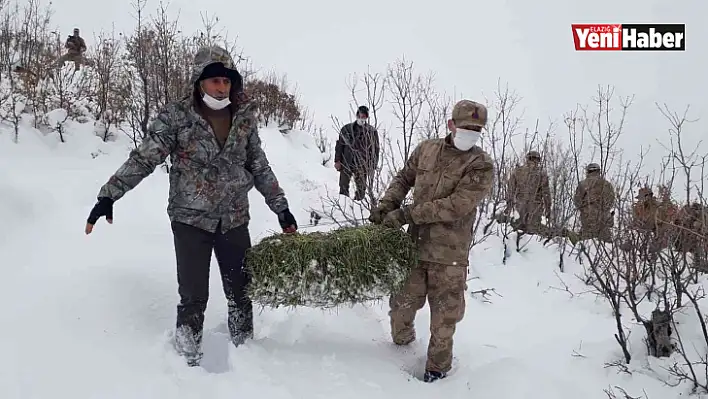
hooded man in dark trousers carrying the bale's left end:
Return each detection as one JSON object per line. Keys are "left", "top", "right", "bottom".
{"left": 86, "top": 46, "right": 297, "bottom": 365}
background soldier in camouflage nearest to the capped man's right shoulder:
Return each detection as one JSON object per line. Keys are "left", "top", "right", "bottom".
{"left": 507, "top": 151, "right": 551, "bottom": 234}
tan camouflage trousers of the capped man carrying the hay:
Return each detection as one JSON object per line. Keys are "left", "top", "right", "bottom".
{"left": 389, "top": 262, "right": 467, "bottom": 373}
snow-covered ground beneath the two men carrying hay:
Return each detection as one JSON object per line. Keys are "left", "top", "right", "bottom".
{"left": 0, "top": 117, "right": 687, "bottom": 399}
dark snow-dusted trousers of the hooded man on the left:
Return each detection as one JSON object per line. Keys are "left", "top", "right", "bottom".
{"left": 172, "top": 222, "right": 253, "bottom": 350}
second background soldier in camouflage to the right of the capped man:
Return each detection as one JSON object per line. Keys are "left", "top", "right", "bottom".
{"left": 573, "top": 163, "right": 615, "bottom": 242}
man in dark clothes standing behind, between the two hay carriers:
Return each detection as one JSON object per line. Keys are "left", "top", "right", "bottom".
{"left": 334, "top": 105, "right": 380, "bottom": 201}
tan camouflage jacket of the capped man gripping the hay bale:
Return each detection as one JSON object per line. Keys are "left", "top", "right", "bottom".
{"left": 380, "top": 136, "right": 494, "bottom": 266}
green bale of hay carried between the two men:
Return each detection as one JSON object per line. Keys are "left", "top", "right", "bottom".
{"left": 246, "top": 225, "right": 418, "bottom": 308}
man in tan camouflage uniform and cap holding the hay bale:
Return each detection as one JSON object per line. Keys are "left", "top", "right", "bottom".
{"left": 369, "top": 100, "right": 494, "bottom": 382}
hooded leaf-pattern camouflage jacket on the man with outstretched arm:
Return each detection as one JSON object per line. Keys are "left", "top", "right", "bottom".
{"left": 98, "top": 47, "right": 288, "bottom": 232}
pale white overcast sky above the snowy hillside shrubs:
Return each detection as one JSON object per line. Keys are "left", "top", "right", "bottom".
{"left": 53, "top": 0, "right": 708, "bottom": 178}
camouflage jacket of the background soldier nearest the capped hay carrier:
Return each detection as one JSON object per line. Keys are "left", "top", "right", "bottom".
{"left": 507, "top": 165, "right": 551, "bottom": 209}
